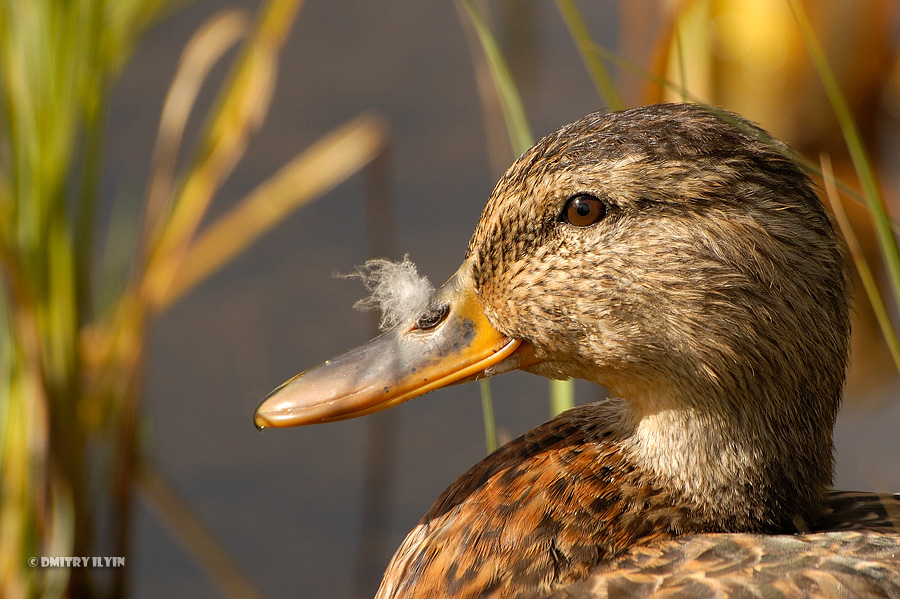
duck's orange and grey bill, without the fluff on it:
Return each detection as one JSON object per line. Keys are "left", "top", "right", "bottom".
{"left": 254, "top": 266, "right": 521, "bottom": 429}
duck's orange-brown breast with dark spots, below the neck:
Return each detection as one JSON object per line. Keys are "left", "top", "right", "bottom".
{"left": 378, "top": 405, "right": 684, "bottom": 597}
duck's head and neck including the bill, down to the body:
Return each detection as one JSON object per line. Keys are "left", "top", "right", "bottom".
{"left": 256, "top": 104, "right": 849, "bottom": 526}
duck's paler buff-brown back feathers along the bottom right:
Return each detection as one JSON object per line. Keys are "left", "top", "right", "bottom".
{"left": 560, "top": 524, "right": 900, "bottom": 599}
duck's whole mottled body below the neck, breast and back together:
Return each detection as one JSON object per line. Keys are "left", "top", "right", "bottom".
{"left": 376, "top": 420, "right": 900, "bottom": 599}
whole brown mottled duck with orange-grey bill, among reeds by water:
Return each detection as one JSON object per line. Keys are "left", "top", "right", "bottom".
{"left": 254, "top": 103, "right": 900, "bottom": 599}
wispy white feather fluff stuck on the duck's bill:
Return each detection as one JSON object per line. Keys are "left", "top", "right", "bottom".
{"left": 341, "top": 256, "right": 434, "bottom": 331}
